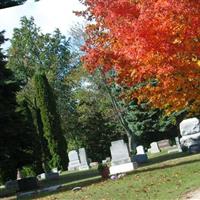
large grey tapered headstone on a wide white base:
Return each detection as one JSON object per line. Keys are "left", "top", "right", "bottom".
{"left": 110, "top": 140, "right": 137, "bottom": 175}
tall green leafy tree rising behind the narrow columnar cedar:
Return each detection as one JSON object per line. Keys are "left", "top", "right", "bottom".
{"left": 7, "top": 17, "right": 73, "bottom": 171}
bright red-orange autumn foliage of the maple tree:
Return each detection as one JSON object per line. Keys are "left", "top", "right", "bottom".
{"left": 77, "top": 0, "right": 200, "bottom": 113}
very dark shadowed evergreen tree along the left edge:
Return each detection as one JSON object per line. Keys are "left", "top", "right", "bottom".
{"left": 0, "top": 32, "right": 41, "bottom": 182}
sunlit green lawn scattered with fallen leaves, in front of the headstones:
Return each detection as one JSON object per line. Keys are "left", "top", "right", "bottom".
{"left": 21, "top": 153, "right": 200, "bottom": 200}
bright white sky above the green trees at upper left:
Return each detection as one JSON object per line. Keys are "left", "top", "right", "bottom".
{"left": 0, "top": 0, "right": 84, "bottom": 47}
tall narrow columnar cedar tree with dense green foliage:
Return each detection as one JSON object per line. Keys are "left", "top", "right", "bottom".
{"left": 34, "top": 73, "right": 68, "bottom": 169}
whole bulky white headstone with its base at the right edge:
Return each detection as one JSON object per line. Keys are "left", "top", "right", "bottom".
{"left": 180, "top": 117, "right": 200, "bottom": 153}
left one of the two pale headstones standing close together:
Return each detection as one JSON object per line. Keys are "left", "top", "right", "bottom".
{"left": 68, "top": 150, "right": 80, "bottom": 171}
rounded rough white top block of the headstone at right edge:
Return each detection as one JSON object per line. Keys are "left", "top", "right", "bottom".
{"left": 180, "top": 117, "right": 200, "bottom": 136}
